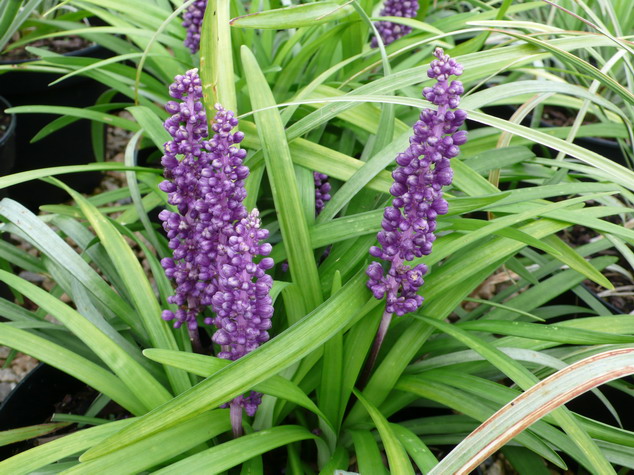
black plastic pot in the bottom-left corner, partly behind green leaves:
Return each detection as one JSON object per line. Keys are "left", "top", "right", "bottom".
{"left": 0, "top": 363, "right": 86, "bottom": 460}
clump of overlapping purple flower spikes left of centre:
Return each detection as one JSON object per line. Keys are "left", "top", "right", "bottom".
{"left": 159, "top": 69, "right": 273, "bottom": 435}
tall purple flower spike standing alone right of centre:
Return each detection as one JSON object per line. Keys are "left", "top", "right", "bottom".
{"left": 367, "top": 48, "right": 467, "bottom": 315}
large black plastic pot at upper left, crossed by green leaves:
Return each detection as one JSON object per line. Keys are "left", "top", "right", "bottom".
{"left": 0, "top": 45, "right": 111, "bottom": 210}
